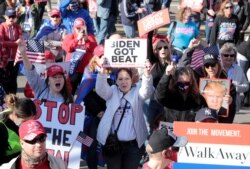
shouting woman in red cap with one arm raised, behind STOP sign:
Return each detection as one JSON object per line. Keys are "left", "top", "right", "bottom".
{"left": 18, "top": 41, "right": 73, "bottom": 103}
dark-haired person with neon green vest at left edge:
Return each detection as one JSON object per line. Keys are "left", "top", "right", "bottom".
{"left": 0, "top": 94, "right": 36, "bottom": 165}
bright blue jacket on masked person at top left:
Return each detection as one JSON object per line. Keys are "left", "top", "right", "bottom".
{"left": 60, "top": 0, "right": 94, "bottom": 35}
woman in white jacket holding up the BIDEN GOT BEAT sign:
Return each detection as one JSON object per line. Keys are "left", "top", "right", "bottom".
{"left": 96, "top": 64, "right": 154, "bottom": 169}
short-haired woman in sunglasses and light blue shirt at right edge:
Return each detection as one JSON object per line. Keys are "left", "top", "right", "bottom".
{"left": 220, "top": 43, "right": 249, "bottom": 112}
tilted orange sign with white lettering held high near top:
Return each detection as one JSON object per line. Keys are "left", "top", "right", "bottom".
{"left": 137, "top": 9, "right": 170, "bottom": 37}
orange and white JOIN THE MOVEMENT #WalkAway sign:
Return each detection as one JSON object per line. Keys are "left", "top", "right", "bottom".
{"left": 173, "top": 121, "right": 250, "bottom": 166}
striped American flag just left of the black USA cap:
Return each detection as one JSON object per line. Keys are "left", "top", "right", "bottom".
{"left": 190, "top": 46, "right": 205, "bottom": 70}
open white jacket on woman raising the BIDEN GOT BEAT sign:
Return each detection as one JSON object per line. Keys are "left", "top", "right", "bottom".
{"left": 96, "top": 74, "right": 154, "bottom": 147}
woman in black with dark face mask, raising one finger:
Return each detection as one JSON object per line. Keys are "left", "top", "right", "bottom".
{"left": 154, "top": 63, "right": 205, "bottom": 122}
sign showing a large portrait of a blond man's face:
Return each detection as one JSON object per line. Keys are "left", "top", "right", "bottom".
{"left": 199, "top": 78, "right": 231, "bottom": 117}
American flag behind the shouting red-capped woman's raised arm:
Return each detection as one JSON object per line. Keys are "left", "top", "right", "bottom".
{"left": 14, "top": 39, "right": 46, "bottom": 65}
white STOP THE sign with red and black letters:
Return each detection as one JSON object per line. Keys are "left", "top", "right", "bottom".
{"left": 34, "top": 100, "right": 85, "bottom": 169}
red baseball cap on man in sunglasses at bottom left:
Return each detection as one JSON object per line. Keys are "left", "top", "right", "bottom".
{"left": 19, "top": 120, "right": 46, "bottom": 141}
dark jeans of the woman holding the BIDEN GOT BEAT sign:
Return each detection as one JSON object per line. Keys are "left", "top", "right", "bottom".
{"left": 104, "top": 141, "right": 145, "bottom": 169}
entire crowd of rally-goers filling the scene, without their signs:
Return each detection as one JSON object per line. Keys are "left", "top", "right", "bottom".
{"left": 0, "top": 0, "right": 250, "bottom": 169}
